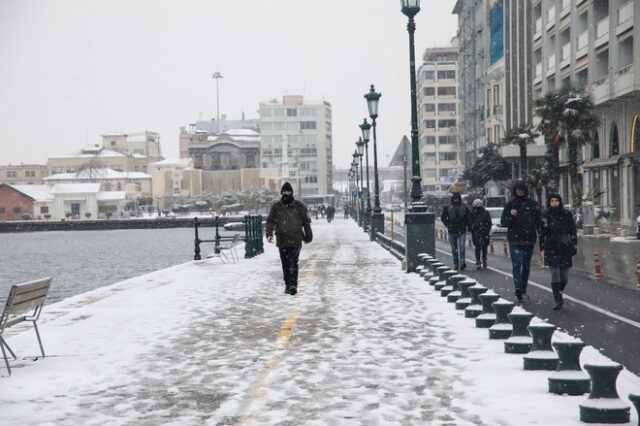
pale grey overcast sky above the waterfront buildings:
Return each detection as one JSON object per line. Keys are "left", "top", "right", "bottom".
{"left": 0, "top": 0, "right": 457, "bottom": 170}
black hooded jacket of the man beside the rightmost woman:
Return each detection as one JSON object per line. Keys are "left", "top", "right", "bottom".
{"left": 500, "top": 181, "right": 542, "bottom": 246}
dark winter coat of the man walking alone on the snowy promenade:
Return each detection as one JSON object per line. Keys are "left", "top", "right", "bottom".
{"left": 267, "top": 200, "right": 313, "bottom": 247}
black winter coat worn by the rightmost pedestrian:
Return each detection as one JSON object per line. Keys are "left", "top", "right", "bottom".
{"left": 540, "top": 207, "right": 578, "bottom": 268}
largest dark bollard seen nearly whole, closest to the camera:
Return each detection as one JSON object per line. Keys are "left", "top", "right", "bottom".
{"left": 580, "top": 362, "right": 631, "bottom": 423}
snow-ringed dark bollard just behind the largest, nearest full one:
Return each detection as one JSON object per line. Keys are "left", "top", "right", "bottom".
{"left": 549, "top": 339, "right": 591, "bottom": 395}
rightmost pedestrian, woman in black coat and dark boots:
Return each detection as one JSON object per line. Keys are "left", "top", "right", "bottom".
{"left": 540, "top": 194, "right": 578, "bottom": 311}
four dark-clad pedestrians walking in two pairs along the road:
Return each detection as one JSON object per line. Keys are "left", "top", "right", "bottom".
{"left": 440, "top": 180, "right": 578, "bottom": 310}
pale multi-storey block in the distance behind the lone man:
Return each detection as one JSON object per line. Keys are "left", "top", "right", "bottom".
{"left": 259, "top": 96, "right": 333, "bottom": 195}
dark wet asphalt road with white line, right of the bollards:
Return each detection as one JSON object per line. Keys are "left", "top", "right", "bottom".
{"left": 387, "top": 224, "right": 640, "bottom": 374}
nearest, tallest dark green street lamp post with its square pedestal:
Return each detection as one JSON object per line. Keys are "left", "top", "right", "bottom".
{"left": 400, "top": 0, "right": 436, "bottom": 272}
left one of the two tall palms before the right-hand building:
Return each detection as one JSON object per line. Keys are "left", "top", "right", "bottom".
{"left": 534, "top": 91, "right": 565, "bottom": 190}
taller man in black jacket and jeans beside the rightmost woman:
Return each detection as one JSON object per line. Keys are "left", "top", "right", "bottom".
{"left": 500, "top": 179, "right": 542, "bottom": 303}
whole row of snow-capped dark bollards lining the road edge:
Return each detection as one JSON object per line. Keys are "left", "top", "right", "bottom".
{"left": 416, "top": 255, "right": 640, "bottom": 426}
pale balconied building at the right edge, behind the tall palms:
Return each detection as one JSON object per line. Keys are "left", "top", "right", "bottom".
{"left": 532, "top": 0, "right": 640, "bottom": 226}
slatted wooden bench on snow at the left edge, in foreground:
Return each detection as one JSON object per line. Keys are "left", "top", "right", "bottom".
{"left": 0, "top": 278, "right": 51, "bottom": 375}
